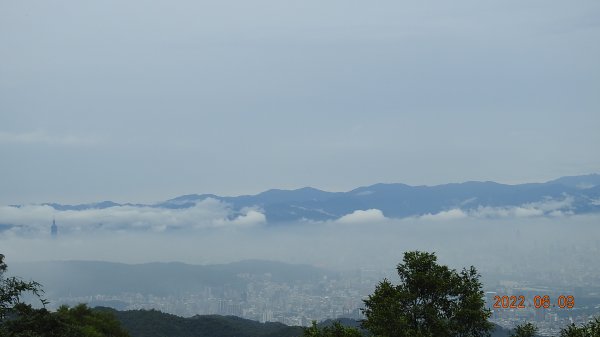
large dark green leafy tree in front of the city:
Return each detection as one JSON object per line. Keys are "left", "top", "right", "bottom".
{"left": 362, "top": 251, "right": 493, "bottom": 337}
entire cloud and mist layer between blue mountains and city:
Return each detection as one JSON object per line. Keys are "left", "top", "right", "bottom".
{"left": 0, "top": 197, "right": 600, "bottom": 284}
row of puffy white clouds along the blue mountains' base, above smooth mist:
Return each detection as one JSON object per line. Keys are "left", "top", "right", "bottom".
{"left": 0, "top": 195, "right": 574, "bottom": 236}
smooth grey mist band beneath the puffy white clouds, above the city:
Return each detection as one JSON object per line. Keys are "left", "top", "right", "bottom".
{"left": 0, "top": 214, "right": 600, "bottom": 285}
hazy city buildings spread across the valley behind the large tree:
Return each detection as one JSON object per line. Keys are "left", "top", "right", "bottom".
{"left": 35, "top": 258, "right": 600, "bottom": 336}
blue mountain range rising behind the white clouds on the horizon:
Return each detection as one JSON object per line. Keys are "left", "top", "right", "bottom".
{"left": 36, "top": 174, "right": 600, "bottom": 224}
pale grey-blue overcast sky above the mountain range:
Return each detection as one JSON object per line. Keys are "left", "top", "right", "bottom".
{"left": 0, "top": 0, "right": 600, "bottom": 204}
